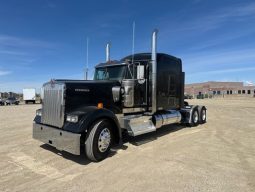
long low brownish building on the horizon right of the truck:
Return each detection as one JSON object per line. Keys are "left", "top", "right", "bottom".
{"left": 185, "top": 81, "right": 255, "bottom": 98}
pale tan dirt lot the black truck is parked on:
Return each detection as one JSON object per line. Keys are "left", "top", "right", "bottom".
{"left": 0, "top": 98, "right": 255, "bottom": 192}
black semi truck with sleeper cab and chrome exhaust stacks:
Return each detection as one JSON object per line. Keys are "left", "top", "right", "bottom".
{"left": 33, "top": 30, "right": 206, "bottom": 161}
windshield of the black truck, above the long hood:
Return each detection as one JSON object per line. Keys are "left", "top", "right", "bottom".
{"left": 94, "top": 65, "right": 126, "bottom": 81}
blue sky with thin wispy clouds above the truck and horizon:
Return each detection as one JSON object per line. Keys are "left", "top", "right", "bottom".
{"left": 0, "top": 0, "right": 255, "bottom": 92}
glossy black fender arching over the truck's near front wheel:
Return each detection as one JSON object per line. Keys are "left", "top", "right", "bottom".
{"left": 63, "top": 106, "right": 122, "bottom": 144}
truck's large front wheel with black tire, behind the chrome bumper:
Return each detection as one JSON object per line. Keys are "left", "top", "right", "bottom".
{"left": 85, "top": 119, "right": 113, "bottom": 161}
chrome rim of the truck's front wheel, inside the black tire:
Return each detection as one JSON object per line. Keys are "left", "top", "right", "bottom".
{"left": 98, "top": 128, "right": 111, "bottom": 153}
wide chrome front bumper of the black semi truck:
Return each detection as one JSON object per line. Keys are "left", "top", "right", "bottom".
{"left": 33, "top": 123, "right": 81, "bottom": 155}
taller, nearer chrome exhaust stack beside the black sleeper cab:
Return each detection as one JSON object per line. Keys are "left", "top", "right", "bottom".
{"left": 151, "top": 29, "right": 158, "bottom": 113}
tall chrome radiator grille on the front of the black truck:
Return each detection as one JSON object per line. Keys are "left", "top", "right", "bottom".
{"left": 42, "top": 82, "right": 65, "bottom": 128}
